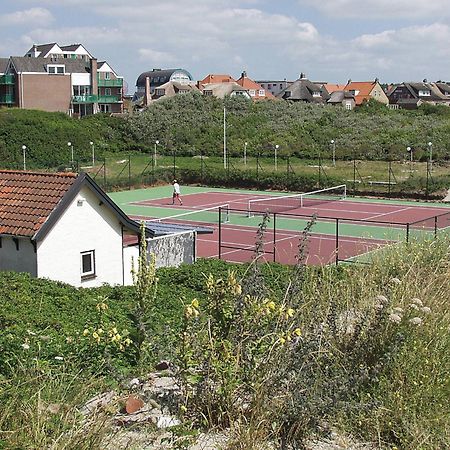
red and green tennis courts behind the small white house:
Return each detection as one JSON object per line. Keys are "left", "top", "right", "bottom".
{"left": 110, "top": 186, "right": 450, "bottom": 265}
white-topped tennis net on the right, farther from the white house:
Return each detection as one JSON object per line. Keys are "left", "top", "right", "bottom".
{"left": 248, "top": 184, "right": 347, "bottom": 217}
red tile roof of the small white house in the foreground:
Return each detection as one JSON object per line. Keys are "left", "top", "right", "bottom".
{"left": 0, "top": 170, "right": 78, "bottom": 237}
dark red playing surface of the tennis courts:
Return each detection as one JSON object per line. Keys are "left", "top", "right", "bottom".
{"left": 133, "top": 191, "right": 450, "bottom": 265}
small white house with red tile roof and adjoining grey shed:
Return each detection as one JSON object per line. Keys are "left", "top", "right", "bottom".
{"left": 0, "top": 170, "right": 213, "bottom": 287}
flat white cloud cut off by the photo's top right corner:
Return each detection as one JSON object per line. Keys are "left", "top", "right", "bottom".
{"left": 298, "top": 0, "right": 450, "bottom": 20}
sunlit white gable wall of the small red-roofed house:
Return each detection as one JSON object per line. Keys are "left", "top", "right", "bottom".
{"left": 37, "top": 187, "right": 123, "bottom": 287}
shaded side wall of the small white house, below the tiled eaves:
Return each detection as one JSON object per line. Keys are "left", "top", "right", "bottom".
{"left": 0, "top": 236, "right": 37, "bottom": 276}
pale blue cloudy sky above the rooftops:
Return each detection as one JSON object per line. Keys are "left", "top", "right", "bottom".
{"left": 0, "top": 0, "right": 450, "bottom": 93}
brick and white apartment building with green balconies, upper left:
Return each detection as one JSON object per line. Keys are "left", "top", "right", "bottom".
{"left": 0, "top": 43, "right": 123, "bottom": 117}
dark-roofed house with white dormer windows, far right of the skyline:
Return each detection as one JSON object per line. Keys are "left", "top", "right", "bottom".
{"left": 389, "top": 80, "right": 449, "bottom": 109}
